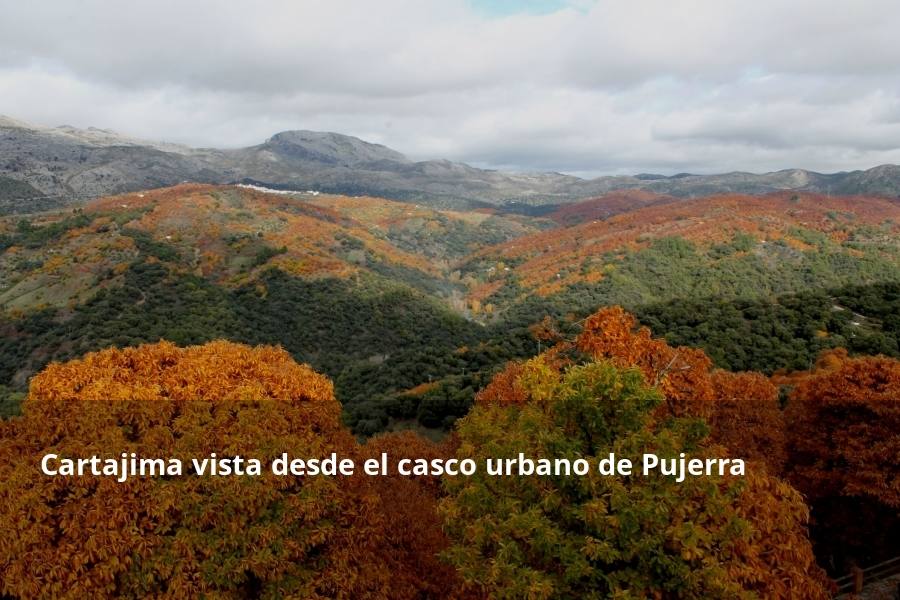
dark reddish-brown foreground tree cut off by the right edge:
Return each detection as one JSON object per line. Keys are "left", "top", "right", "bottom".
{"left": 787, "top": 352, "right": 900, "bottom": 571}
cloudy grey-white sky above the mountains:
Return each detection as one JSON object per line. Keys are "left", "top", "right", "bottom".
{"left": 0, "top": 0, "right": 900, "bottom": 175}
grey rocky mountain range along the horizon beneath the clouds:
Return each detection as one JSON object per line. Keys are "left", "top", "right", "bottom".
{"left": 0, "top": 116, "right": 900, "bottom": 212}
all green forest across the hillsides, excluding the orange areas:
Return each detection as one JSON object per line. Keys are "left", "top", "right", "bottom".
{"left": 0, "top": 202, "right": 900, "bottom": 435}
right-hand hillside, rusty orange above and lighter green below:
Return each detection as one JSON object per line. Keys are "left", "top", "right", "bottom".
{"left": 464, "top": 194, "right": 900, "bottom": 302}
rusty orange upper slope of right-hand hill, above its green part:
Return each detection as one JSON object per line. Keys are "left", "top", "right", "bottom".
{"left": 469, "top": 193, "right": 900, "bottom": 298}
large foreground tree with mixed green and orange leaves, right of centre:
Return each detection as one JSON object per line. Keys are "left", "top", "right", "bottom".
{"left": 440, "top": 357, "right": 828, "bottom": 599}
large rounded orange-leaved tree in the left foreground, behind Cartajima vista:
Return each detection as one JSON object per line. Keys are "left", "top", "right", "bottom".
{"left": 0, "top": 342, "right": 393, "bottom": 599}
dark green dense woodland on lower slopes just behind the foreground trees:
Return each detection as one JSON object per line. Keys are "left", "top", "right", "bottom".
{"left": 0, "top": 262, "right": 900, "bottom": 434}
